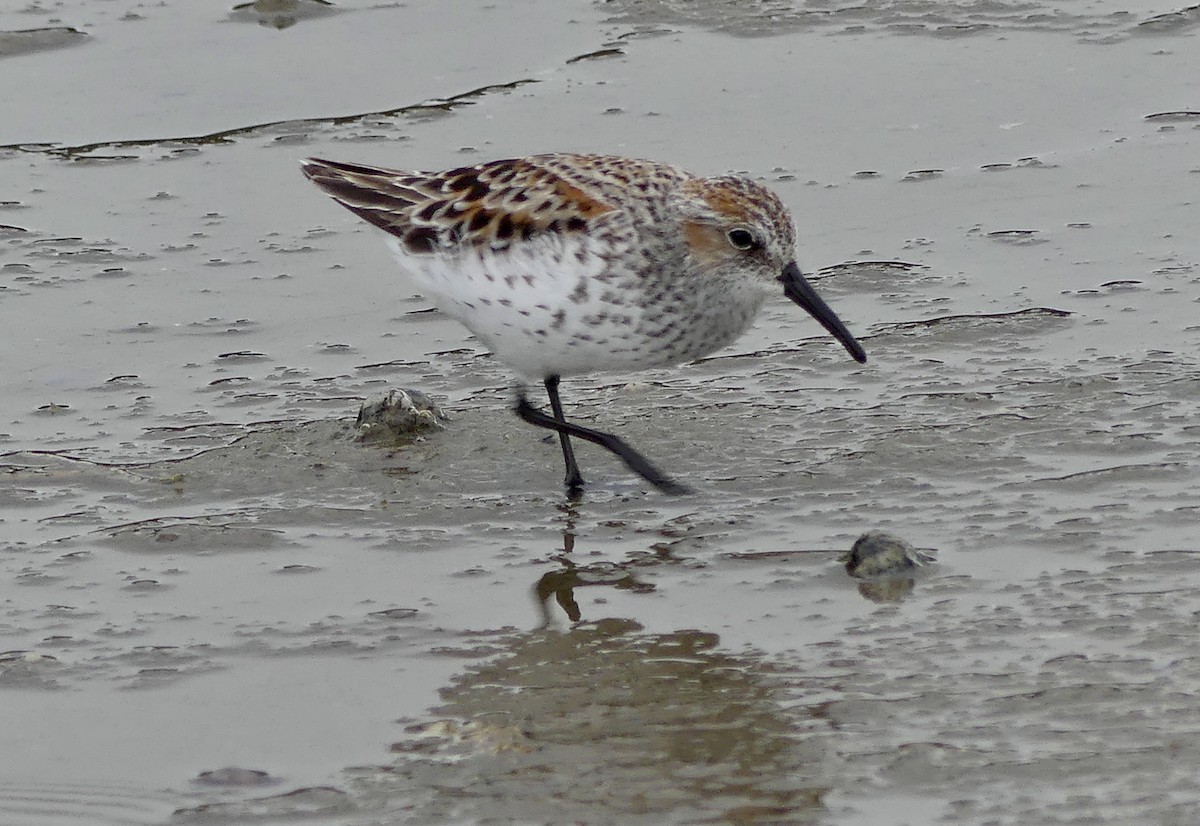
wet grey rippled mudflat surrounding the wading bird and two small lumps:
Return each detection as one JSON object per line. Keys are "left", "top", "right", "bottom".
{"left": 0, "top": 0, "right": 1200, "bottom": 826}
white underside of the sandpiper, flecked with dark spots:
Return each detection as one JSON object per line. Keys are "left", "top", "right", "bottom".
{"left": 388, "top": 230, "right": 763, "bottom": 379}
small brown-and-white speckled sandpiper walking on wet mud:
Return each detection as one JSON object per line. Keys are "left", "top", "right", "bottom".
{"left": 301, "top": 152, "right": 866, "bottom": 495}
